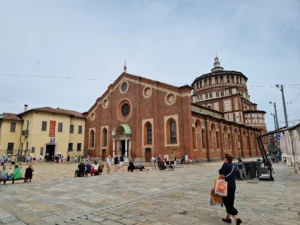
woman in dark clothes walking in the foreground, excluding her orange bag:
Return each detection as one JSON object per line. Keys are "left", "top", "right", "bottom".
{"left": 219, "top": 153, "right": 242, "bottom": 225}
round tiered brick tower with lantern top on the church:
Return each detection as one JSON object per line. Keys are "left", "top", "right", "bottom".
{"left": 192, "top": 56, "right": 265, "bottom": 127}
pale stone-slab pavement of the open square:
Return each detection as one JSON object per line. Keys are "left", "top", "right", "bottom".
{"left": 0, "top": 159, "right": 300, "bottom": 225}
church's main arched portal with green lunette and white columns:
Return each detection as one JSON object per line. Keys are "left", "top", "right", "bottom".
{"left": 112, "top": 124, "right": 131, "bottom": 157}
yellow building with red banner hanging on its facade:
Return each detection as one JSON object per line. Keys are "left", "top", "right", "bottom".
{"left": 18, "top": 105, "right": 85, "bottom": 160}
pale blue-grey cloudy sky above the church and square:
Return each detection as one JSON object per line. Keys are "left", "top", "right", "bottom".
{"left": 0, "top": 0, "right": 300, "bottom": 130}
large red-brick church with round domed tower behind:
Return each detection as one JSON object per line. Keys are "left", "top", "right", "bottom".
{"left": 85, "top": 57, "right": 266, "bottom": 162}
